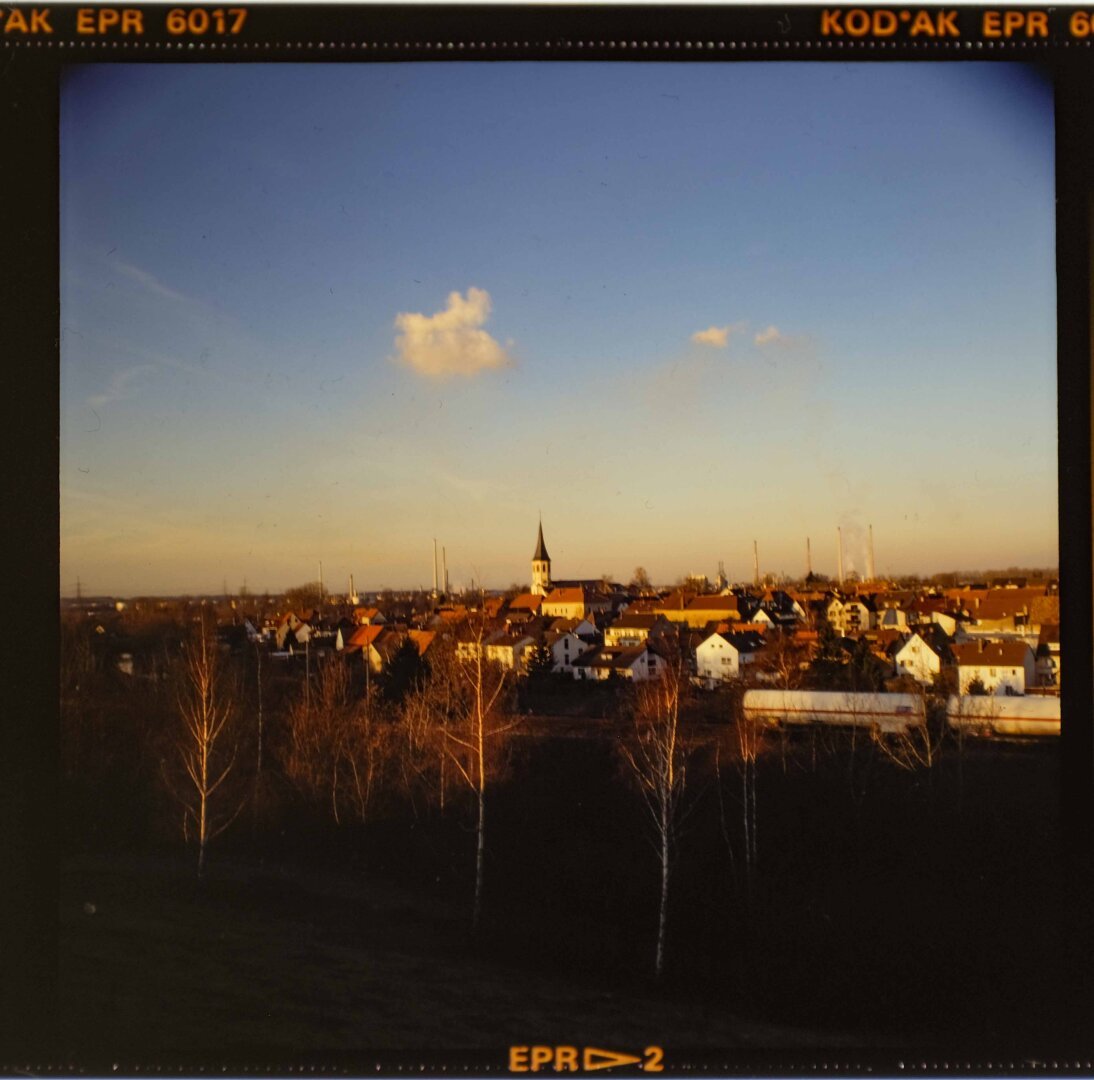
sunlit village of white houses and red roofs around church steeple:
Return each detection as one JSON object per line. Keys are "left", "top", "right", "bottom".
{"left": 68, "top": 524, "right": 1061, "bottom": 696}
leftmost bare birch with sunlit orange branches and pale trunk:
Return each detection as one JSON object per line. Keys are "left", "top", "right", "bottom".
{"left": 164, "top": 618, "right": 245, "bottom": 878}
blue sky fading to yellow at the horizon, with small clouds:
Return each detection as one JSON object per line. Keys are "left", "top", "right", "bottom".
{"left": 60, "top": 63, "right": 1057, "bottom": 595}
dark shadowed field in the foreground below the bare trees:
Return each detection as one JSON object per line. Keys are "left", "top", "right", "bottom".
{"left": 57, "top": 733, "right": 1063, "bottom": 1068}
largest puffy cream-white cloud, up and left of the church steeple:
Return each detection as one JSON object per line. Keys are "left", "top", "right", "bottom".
{"left": 395, "top": 287, "right": 513, "bottom": 379}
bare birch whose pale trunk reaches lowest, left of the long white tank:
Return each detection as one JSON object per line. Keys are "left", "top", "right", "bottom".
{"left": 620, "top": 663, "right": 687, "bottom": 978}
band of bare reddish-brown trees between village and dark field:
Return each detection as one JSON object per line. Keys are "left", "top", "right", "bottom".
{"left": 60, "top": 613, "right": 975, "bottom": 975}
